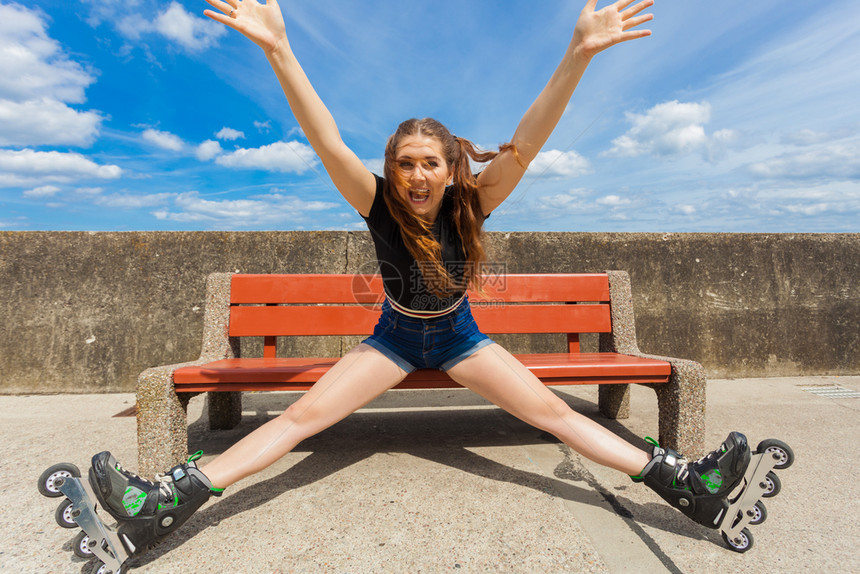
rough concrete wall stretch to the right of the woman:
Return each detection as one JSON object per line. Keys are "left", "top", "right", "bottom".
{"left": 491, "top": 233, "right": 860, "bottom": 378}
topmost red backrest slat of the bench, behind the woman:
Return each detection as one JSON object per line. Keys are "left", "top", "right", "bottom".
{"left": 230, "top": 273, "right": 609, "bottom": 304}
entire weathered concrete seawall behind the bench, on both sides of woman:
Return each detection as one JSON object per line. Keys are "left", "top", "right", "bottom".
{"left": 0, "top": 231, "right": 860, "bottom": 394}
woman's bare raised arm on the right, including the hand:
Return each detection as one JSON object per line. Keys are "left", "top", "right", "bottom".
{"left": 478, "top": 0, "right": 654, "bottom": 213}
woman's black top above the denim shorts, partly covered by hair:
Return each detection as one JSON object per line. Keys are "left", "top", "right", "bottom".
{"left": 362, "top": 176, "right": 488, "bottom": 317}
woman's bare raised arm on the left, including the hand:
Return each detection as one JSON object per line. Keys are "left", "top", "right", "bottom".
{"left": 204, "top": 0, "right": 376, "bottom": 215}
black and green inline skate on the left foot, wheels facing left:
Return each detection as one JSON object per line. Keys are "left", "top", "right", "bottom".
{"left": 39, "top": 452, "right": 221, "bottom": 574}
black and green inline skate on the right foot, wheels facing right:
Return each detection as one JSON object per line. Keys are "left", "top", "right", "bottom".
{"left": 633, "top": 432, "right": 794, "bottom": 552}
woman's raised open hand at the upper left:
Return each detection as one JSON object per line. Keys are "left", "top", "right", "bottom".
{"left": 203, "top": 0, "right": 287, "bottom": 53}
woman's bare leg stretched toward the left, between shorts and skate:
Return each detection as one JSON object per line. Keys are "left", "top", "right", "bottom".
{"left": 200, "top": 344, "right": 406, "bottom": 488}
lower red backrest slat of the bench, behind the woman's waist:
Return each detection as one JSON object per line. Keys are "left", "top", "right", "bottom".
{"left": 229, "top": 305, "right": 612, "bottom": 337}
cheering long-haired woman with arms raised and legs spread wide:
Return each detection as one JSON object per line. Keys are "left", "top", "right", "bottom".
{"left": 82, "top": 0, "right": 750, "bottom": 568}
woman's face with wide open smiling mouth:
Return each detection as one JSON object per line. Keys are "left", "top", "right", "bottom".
{"left": 394, "top": 135, "right": 453, "bottom": 221}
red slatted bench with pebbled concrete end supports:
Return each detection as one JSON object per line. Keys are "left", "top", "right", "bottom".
{"left": 138, "top": 272, "right": 705, "bottom": 475}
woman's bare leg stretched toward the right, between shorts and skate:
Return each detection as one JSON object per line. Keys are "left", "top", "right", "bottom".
{"left": 448, "top": 344, "right": 650, "bottom": 476}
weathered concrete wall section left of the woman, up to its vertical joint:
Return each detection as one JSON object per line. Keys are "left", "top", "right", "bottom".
{"left": 0, "top": 232, "right": 347, "bottom": 393}
